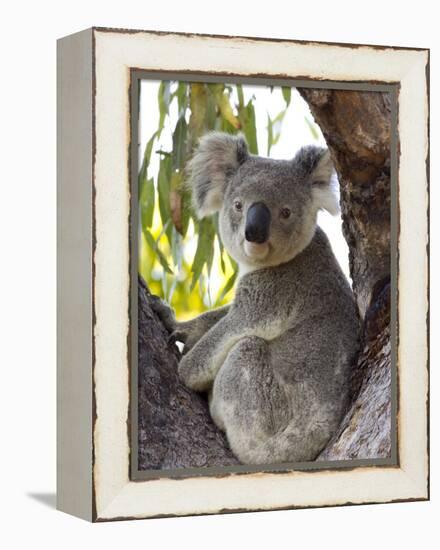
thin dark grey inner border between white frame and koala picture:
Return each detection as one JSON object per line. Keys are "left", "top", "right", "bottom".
{"left": 128, "top": 68, "right": 399, "bottom": 481}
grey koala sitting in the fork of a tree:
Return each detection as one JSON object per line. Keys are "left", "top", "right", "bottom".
{"left": 156, "top": 132, "right": 359, "bottom": 464}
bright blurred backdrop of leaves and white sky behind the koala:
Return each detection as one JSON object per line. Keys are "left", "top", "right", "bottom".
{"left": 138, "top": 83, "right": 350, "bottom": 320}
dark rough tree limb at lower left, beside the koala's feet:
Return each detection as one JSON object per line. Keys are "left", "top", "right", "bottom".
{"left": 138, "top": 278, "right": 238, "bottom": 470}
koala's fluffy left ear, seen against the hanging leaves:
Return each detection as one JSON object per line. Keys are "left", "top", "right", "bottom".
{"left": 188, "top": 132, "right": 249, "bottom": 218}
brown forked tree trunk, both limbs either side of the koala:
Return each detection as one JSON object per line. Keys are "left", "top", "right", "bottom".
{"left": 138, "top": 89, "right": 391, "bottom": 470}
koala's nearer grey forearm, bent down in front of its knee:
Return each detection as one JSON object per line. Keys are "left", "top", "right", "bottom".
{"left": 179, "top": 314, "right": 243, "bottom": 391}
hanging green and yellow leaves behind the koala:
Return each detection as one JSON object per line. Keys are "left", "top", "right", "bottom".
{"left": 139, "top": 81, "right": 298, "bottom": 317}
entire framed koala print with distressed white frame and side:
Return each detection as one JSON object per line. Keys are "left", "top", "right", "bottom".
{"left": 57, "top": 28, "right": 429, "bottom": 521}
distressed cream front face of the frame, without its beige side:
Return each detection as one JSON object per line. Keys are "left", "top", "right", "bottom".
{"left": 56, "top": 29, "right": 429, "bottom": 520}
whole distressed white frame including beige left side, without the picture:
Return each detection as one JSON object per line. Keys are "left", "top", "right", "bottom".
{"left": 57, "top": 28, "right": 429, "bottom": 521}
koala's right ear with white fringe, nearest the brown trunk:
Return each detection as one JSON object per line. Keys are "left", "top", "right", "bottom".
{"left": 294, "top": 146, "right": 339, "bottom": 216}
